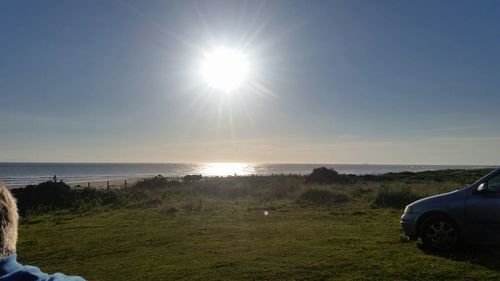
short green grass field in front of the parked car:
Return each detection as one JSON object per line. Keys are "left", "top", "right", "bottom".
{"left": 13, "top": 170, "right": 500, "bottom": 281}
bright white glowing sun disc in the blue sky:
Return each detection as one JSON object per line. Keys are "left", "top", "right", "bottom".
{"left": 201, "top": 47, "right": 250, "bottom": 93}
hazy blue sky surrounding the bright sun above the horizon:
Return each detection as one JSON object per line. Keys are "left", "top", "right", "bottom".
{"left": 0, "top": 0, "right": 500, "bottom": 165}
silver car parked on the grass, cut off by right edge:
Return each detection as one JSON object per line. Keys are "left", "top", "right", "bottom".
{"left": 401, "top": 168, "right": 500, "bottom": 250}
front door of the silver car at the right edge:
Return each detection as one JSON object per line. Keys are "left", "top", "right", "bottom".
{"left": 464, "top": 174, "right": 500, "bottom": 243}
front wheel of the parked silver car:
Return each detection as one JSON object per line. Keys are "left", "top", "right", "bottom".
{"left": 420, "top": 215, "right": 460, "bottom": 251}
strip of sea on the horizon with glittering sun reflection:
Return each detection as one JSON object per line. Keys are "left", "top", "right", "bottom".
{"left": 0, "top": 163, "right": 487, "bottom": 186}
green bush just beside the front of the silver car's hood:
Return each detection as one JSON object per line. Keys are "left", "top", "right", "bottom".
{"left": 372, "top": 187, "right": 422, "bottom": 209}
